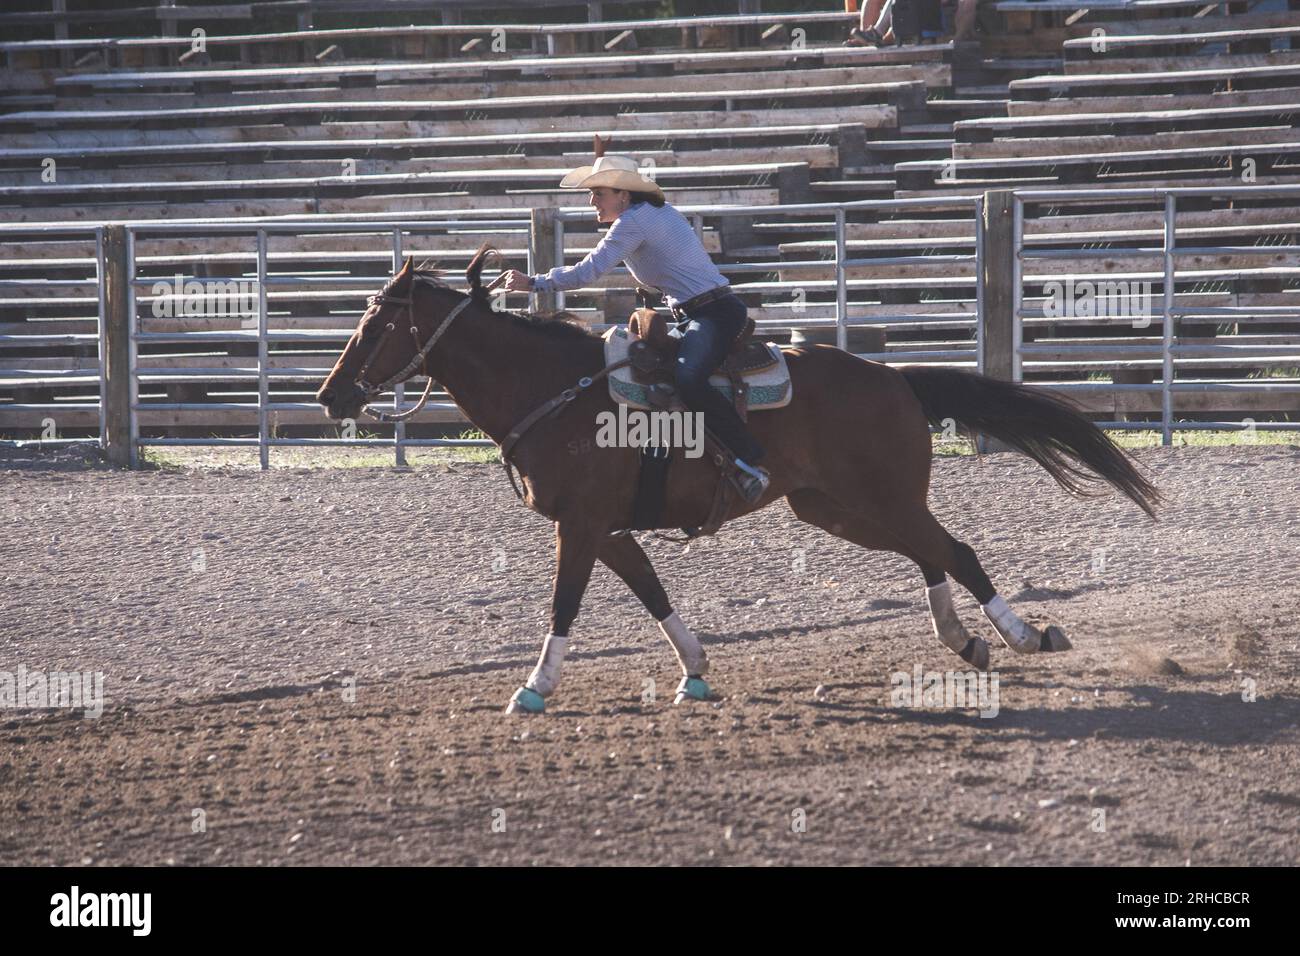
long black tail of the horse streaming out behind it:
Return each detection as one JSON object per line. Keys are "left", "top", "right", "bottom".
{"left": 902, "top": 365, "right": 1161, "bottom": 518}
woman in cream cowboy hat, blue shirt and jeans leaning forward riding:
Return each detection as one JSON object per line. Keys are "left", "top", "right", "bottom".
{"left": 504, "top": 155, "right": 771, "bottom": 505}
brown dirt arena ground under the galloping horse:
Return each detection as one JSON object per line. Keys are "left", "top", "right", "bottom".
{"left": 0, "top": 445, "right": 1300, "bottom": 866}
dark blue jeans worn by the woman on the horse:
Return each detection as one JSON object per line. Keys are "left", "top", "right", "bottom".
{"left": 676, "top": 295, "right": 763, "bottom": 464}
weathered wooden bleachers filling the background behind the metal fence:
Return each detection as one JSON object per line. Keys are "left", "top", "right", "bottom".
{"left": 0, "top": 0, "right": 1300, "bottom": 434}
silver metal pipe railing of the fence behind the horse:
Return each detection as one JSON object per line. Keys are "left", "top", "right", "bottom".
{"left": 0, "top": 186, "right": 1300, "bottom": 467}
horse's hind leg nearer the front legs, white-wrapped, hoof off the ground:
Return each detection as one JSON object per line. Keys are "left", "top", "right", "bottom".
{"left": 787, "top": 489, "right": 988, "bottom": 670}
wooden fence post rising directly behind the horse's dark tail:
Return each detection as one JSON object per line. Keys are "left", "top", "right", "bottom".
{"left": 976, "top": 189, "right": 1019, "bottom": 451}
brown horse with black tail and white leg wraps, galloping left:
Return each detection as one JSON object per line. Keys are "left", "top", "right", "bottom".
{"left": 316, "top": 251, "right": 1160, "bottom": 713}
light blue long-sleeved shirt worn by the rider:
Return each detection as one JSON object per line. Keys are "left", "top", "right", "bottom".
{"left": 530, "top": 202, "right": 727, "bottom": 306}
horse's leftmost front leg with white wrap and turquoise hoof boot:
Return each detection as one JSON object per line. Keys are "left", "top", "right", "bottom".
{"left": 506, "top": 519, "right": 605, "bottom": 714}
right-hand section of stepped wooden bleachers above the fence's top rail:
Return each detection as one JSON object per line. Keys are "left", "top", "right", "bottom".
{"left": 897, "top": 0, "right": 1300, "bottom": 196}
